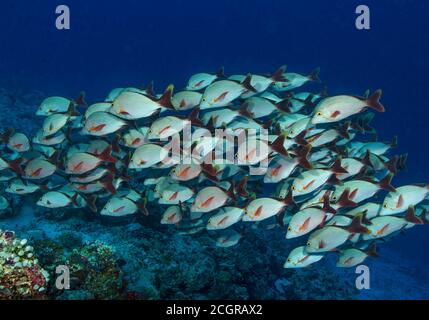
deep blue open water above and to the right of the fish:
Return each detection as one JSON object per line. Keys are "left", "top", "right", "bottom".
{"left": 0, "top": 0, "right": 429, "bottom": 298}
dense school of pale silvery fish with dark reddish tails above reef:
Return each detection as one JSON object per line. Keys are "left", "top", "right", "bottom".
{"left": 0, "top": 66, "right": 429, "bottom": 268}
